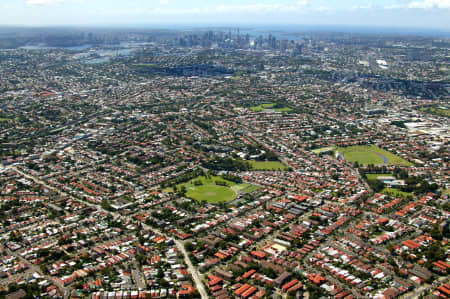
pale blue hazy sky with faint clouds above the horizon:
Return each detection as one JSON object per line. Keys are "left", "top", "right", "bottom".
{"left": 0, "top": 0, "right": 450, "bottom": 32}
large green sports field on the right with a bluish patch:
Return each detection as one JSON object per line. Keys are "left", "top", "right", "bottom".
{"left": 337, "top": 145, "right": 413, "bottom": 166}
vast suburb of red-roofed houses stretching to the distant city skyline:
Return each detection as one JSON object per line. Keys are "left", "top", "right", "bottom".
{"left": 0, "top": 30, "right": 450, "bottom": 299}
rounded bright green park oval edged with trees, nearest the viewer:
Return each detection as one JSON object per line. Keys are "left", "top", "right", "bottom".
{"left": 164, "top": 176, "right": 237, "bottom": 203}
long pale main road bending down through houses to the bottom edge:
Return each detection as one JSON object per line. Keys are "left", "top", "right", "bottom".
{"left": 8, "top": 166, "right": 208, "bottom": 299}
